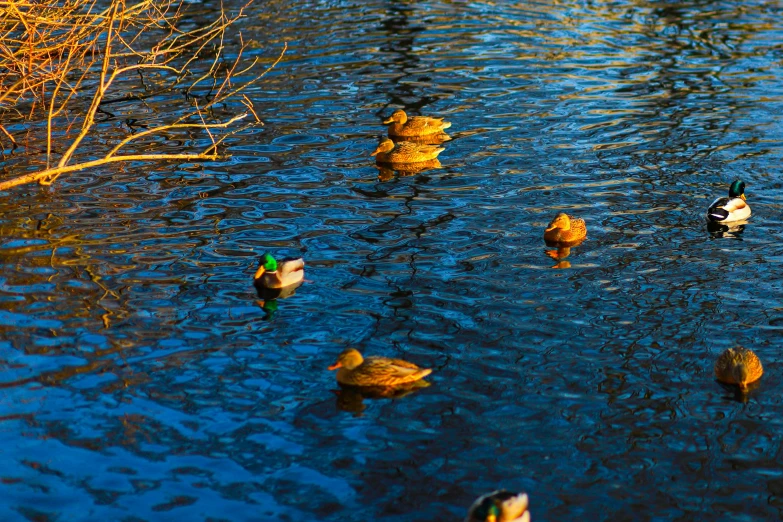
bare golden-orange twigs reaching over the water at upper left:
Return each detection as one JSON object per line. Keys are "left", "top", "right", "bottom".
{"left": 0, "top": 0, "right": 287, "bottom": 190}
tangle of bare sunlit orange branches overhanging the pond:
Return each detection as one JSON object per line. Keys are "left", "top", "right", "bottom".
{"left": 0, "top": 0, "right": 286, "bottom": 190}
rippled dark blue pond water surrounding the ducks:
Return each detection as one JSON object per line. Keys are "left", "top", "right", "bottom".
{"left": 0, "top": 0, "right": 783, "bottom": 522}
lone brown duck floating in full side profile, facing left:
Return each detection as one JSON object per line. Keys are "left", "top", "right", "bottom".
{"left": 329, "top": 348, "right": 432, "bottom": 386}
